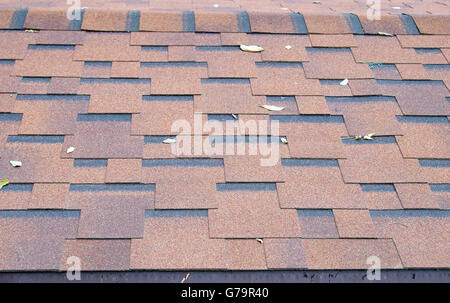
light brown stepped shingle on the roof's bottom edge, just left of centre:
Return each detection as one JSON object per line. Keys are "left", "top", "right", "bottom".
{"left": 130, "top": 216, "right": 229, "bottom": 270}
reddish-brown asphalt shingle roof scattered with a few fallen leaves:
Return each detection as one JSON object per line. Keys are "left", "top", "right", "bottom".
{"left": 0, "top": 1, "right": 450, "bottom": 271}
